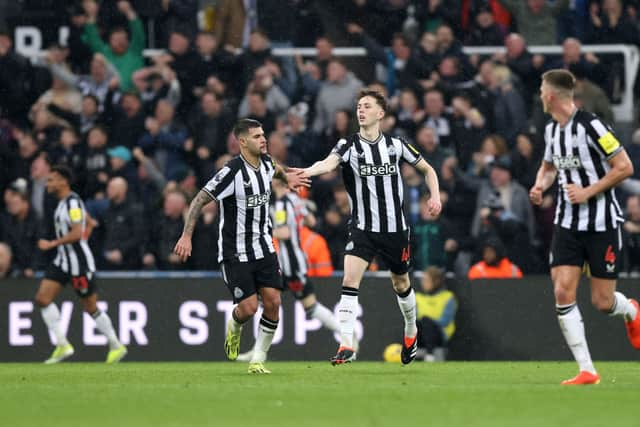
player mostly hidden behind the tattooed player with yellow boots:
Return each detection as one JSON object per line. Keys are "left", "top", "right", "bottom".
{"left": 238, "top": 178, "right": 342, "bottom": 361}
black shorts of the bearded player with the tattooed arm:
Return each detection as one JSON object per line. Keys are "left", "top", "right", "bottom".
{"left": 220, "top": 254, "right": 282, "bottom": 304}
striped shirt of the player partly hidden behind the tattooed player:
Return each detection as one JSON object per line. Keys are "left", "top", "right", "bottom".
{"left": 271, "top": 193, "right": 307, "bottom": 283}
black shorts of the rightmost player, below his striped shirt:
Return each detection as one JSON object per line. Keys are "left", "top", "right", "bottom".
{"left": 549, "top": 226, "right": 622, "bottom": 279}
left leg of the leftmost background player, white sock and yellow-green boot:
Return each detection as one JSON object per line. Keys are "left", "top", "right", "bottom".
{"left": 35, "top": 268, "right": 74, "bottom": 364}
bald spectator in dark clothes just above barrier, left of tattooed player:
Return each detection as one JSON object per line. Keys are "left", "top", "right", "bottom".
{"left": 142, "top": 190, "right": 187, "bottom": 270}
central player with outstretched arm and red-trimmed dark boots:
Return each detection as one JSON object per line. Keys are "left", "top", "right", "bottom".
{"left": 296, "top": 90, "right": 442, "bottom": 365}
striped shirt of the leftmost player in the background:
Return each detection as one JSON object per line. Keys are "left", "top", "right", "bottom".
{"left": 53, "top": 193, "right": 96, "bottom": 276}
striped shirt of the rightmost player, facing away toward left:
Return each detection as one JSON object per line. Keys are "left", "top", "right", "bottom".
{"left": 544, "top": 110, "right": 624, "bottom": 231}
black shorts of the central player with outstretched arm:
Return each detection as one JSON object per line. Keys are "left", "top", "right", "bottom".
{"left": 344, "top": 227, "right": 411, "bottom": 274}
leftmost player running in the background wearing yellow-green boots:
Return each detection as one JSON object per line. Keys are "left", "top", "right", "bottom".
{"left": 35, "top": 166, "right": 127, "bottom": 364}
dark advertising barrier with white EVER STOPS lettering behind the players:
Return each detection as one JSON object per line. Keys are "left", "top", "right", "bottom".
{"left": 0, "top": 273, "right": 638, "bottom": 362}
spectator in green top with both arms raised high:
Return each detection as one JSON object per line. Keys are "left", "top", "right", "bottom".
{"left": 83, "top": 0, "right": 145, "bottom": 91}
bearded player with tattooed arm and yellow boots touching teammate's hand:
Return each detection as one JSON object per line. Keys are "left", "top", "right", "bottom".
{"left": 174, "top": 119, "right": 308, "bottom": 374}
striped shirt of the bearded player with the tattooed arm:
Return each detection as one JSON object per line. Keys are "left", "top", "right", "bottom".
{"left": 202, "top": 154, "right": 275, "bottom": 262}
